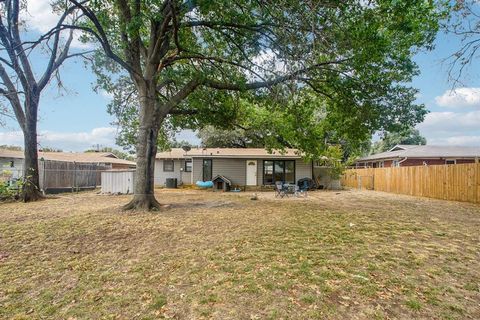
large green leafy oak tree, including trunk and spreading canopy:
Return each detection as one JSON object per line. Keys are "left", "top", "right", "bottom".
{"left": 70, "top": 0, "right": 439, "bottom": 209}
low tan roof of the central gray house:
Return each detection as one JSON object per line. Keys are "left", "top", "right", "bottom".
{"left": 156, "top": 148, "right": 302, "bottom": 159}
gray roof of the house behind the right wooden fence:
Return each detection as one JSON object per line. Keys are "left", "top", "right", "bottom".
{"left": 356, "top": 145, "right": 480, "bottom": 162}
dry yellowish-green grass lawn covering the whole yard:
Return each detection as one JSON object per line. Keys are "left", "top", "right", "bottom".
{"left": 0, "top": 190, "right": 480, "bottom": 319}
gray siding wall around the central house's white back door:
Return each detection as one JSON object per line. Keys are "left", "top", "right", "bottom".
{"left": 189, "top": 157, "right": 312, "bottom": 186}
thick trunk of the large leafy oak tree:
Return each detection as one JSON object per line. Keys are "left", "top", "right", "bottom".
{"left": 123, "top": 86, "right": 161, "bottom": 210}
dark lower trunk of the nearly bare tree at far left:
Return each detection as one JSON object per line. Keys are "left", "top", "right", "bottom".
{"left": 20, "top": 99, "right": 43, "bottom": 202}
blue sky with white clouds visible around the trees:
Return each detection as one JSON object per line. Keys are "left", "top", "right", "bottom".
{"left": 0, "top": 0, "right": 480, "bottom": 151}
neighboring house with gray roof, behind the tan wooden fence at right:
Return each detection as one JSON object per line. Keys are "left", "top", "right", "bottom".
{"left": 355, "top": 145, "right": 480, "bottom": 168}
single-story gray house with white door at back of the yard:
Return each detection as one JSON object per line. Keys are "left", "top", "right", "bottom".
{"left": 155, "top": 148, "right": 340, "bottom": 187}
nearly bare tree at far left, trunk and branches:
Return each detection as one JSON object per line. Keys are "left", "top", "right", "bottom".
{"left": 0, "top": 0, "right": 83, "bottom": 202}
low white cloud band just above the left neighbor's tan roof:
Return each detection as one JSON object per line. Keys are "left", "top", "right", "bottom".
{"left": 0, "top": 127, "right": 117, "bottom": 151}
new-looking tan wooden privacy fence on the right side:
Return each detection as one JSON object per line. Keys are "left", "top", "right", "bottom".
{"left": 342, "top": 163, "right": 480, "bottom": 203}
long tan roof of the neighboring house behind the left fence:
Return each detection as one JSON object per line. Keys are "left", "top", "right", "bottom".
{"left": 0, "top": 149, "right": 136, "bottom": 166}
